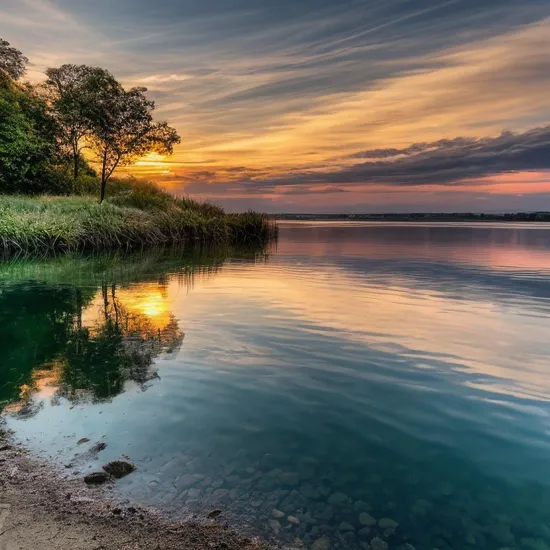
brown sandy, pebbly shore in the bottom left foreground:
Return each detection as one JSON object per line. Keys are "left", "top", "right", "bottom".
{"left": 0, "top": 428, "right": 267, "bottom": 550}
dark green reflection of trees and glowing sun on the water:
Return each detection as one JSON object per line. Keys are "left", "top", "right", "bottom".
{"left": 0, "top": 251, "right": 264, "bottom": 412}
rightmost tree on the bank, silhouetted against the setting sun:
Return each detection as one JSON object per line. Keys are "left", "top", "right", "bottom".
{"left": 90, "top": 85, "right": 180, "bottom": 202}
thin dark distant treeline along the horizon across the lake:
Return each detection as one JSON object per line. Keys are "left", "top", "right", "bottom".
{"left": 278, "top": 212, "right": 550, "bottom": 222}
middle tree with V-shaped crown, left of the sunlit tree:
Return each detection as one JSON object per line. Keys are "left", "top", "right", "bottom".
{"left": 44, "top": 64, "right": 119, "bottom": 180}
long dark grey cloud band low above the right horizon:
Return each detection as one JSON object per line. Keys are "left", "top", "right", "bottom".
{"left": 260, "top": 125, "right": 550, "bottom": 190}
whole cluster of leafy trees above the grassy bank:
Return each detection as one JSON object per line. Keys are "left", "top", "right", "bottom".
{"left": 0, "top": 38, "right": 180, "bottom": 201}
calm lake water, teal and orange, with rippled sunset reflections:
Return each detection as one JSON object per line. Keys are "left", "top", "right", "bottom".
{"left": 0, "top": 223, "right": 550, "bottom": 550}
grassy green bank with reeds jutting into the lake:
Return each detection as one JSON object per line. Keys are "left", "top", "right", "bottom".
{"left": 0, "top": 182, "right": 277, "bottom": 258}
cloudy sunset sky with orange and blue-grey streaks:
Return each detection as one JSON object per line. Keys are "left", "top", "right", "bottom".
{"left": 0, "top": 0, "right": 550, "bottom": 213}
